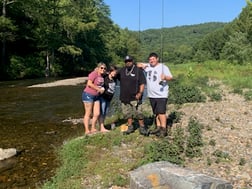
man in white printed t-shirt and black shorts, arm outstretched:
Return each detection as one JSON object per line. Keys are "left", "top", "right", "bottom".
{"left": 137, "top": 53, "right": 172, "bottom": 137}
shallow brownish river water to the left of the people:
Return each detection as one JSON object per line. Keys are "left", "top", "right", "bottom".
{"left": 0, "top": 80, "right": 84, "bottom": 189}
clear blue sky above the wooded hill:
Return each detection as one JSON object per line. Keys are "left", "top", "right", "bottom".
{"left": 104, "top": 0, "right": 247, "bottom": 31}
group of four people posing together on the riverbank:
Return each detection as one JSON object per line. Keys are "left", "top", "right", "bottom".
{"left": 82, "top": 53, "right": 172, "bottom": 137}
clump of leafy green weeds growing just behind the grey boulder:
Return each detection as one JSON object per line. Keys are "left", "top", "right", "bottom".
{"left": 143, "top": 118, "right": 203, "bottom": 164}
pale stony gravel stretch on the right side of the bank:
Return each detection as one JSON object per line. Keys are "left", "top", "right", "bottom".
{"left": 170, "top": 82, "right": 252, "bottom": 189}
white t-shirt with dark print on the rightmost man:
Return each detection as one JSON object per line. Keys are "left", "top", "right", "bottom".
{"left": 144, "top": 63, "right": 172, "bottom": 98}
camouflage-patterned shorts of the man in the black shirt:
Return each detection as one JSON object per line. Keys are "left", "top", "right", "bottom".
{"left": 122, "top": 101, "right": 144, "bottom": 119}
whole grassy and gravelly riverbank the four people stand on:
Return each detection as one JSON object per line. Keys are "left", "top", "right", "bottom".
{"left": 39, "top": 62, "right": 252, "bottom": 189}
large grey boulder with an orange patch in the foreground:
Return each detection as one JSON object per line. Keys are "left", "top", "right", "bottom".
{"left": 130, "top": 161, "right": 233, "bottom": 189}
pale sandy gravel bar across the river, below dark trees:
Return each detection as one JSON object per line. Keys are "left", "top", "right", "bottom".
{"left": 28, "top": 77, "right": 87, "bottom": 88}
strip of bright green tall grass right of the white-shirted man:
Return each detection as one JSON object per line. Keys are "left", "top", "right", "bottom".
{"left": 168, "top": 61, "right": 252, "bottom": 89}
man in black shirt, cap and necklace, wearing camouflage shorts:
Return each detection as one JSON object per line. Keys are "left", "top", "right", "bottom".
{"left": 118, "top": 56, "right": 149, "bottom": 136}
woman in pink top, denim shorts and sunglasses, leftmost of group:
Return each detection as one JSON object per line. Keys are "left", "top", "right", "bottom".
{"left": 82, "top": 62, "right": 106, "bottom": 135}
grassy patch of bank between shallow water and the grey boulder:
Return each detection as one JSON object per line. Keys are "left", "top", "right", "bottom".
{"left": 41, "top": 128, "right": 151, "bottom": 189}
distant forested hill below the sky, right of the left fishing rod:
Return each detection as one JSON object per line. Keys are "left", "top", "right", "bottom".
{"left": 136, "top": 22, "right": 226, "bottom": 61}
